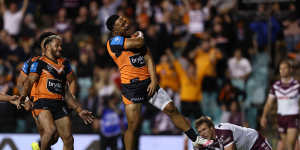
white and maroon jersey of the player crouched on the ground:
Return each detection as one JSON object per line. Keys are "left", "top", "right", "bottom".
{"left": 215, "top": 123, "right": 258, "bottom": 150}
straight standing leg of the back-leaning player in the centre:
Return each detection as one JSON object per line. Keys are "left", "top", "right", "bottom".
{"left": 124, "top": 104, "right": 142, "bottom": 150}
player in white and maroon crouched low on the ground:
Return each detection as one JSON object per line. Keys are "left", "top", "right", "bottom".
{"left": 195, "top": 117, "right": 272, "bottom": 150}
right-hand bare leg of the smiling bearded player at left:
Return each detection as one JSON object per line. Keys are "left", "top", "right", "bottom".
{"left": 55, "top": 116, "right": 74, "bottom": 150}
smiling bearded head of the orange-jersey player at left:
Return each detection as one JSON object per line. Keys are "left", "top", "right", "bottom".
{"left": 41, "top": 34, "right": 62, "bottom": 58}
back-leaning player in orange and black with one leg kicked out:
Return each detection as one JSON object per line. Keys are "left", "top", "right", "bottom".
{"left": 106, "top": 15, "right": 213, "bottom": 150}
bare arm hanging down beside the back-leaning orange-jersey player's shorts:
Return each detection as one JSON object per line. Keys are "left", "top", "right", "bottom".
{"left": 144, "top": 49, "right": 158, "bottom": 96}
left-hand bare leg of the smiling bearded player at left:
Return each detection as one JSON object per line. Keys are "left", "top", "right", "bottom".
{"left": 38, "top": 110, "right": 56, "bottom": 150}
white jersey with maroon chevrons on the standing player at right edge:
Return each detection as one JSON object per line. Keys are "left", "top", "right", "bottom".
{"left": 269, "top": 79, "right": 300, "bottom": 115}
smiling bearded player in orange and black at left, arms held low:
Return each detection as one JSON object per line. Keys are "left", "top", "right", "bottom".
{"left": 21, "top": 35, "right": 93, "bottom": 150}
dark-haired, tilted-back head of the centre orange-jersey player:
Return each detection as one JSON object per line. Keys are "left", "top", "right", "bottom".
{"left": 106, "top": 15, "right": 129, "bottom": 35}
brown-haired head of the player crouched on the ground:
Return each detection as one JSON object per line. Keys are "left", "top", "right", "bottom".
{"left": 195, "top": 116, "right": 215, "bottom": 139}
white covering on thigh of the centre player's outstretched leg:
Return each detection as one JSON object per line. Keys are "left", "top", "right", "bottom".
{"left": 149, "top": 88, "right": 172, "bottom": 110}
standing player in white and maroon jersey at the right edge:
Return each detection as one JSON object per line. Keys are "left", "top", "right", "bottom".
{"left": 260, "top": 60, "right": 300, "bottom": 150}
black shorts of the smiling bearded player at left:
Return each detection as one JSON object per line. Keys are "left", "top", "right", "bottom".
{"left": 32, "top": 99, "right": 70, "bottom": 120}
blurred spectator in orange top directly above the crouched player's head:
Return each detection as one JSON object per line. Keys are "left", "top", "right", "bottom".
{"left": 190, "top": 39, "right": 222, "bottom": 120}
